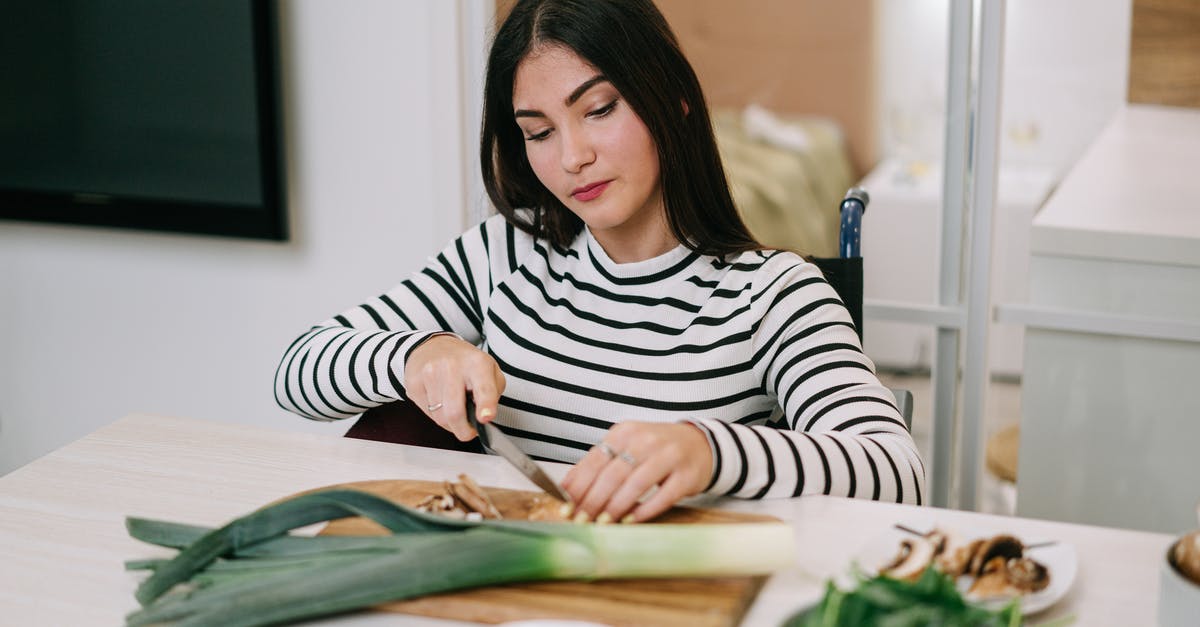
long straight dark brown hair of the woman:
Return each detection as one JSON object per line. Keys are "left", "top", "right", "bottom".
{"left": 479, "top": 0, "right": 762, "bottom": 256}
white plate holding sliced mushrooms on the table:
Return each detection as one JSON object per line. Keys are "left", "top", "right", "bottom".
{"left": 854, "top": 521, "right": 1079, "bottom": 615}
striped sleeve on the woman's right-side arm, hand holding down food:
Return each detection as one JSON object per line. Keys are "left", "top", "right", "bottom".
{"left": 694, "top": 256, "right": 925, "bottom": 504}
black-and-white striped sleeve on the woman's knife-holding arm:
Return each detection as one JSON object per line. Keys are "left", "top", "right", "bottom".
{"left": 275, "top": 219, "right": 514, "bottom": 420}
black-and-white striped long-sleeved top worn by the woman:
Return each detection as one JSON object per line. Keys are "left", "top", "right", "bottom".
{"left": 275, "top": 216, "right": 924, "bottom": 503}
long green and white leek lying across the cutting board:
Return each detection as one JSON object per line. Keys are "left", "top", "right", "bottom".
{"left": 126, "top": 489, "right": 794, "bottom": 626}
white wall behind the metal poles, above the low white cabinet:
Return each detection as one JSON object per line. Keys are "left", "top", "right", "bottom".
{"left": 876, "top": 0, "right": 1133, "bottom": 178}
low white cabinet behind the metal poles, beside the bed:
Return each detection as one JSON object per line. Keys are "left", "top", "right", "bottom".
{"left": 862, "top": 159, "right": 1054, "bottom": 375}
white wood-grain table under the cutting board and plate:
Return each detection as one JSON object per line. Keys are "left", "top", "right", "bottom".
{"left": 0, "top": 414, "right": 1171, "bottom": 626}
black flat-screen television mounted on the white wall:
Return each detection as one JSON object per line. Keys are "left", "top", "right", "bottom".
{"left": 0, "top": 0, "right": 287, "bottom": 240}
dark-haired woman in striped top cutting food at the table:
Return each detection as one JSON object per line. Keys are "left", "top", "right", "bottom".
{"left": 276, "top": 0, "right": 924, "bottom": 521}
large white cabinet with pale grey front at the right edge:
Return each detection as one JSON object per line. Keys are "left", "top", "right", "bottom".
{"left": 1000, "top": 106, "right": 1200, "bottom": 532}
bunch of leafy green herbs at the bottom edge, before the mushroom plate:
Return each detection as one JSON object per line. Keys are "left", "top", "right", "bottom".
{"left": 785, "top": 567, "right": 1021, "bottom": 627}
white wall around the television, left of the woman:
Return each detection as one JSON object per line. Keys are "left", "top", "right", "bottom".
{"left": 0, "top": 0, "right": 472, "bottom": 473}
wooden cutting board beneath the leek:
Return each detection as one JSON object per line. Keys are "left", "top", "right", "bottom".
{"left": 309, "top": 479, "right": 778, "bottom": 627}
